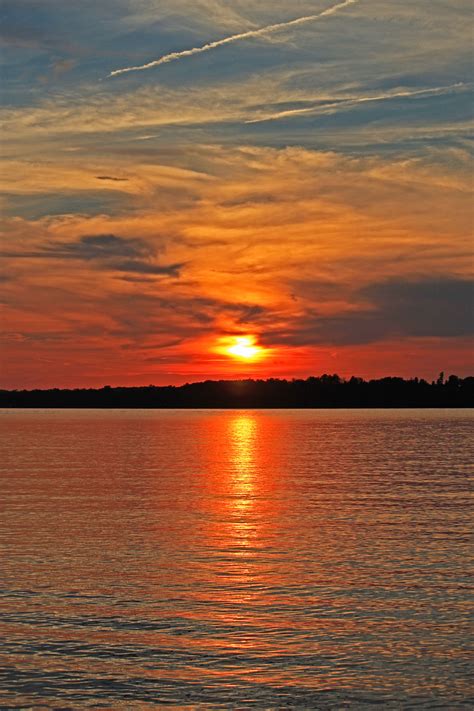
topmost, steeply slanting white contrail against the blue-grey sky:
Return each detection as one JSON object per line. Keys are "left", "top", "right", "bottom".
{"left": 108, "top": 0, "right": 359, "bottom": 77}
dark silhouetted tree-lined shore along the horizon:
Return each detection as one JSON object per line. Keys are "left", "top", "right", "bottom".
{"left": 0, "top": 373, "right": 474, "bottom": 409}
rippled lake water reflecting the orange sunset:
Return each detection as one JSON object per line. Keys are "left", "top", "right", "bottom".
{"left": 0, "top": 410, "right": 474, "bottom": 709}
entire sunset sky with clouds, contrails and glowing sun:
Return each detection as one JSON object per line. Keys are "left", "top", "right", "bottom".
{"left": 0, "top": 0, "right": 473, "bottom": 388}
